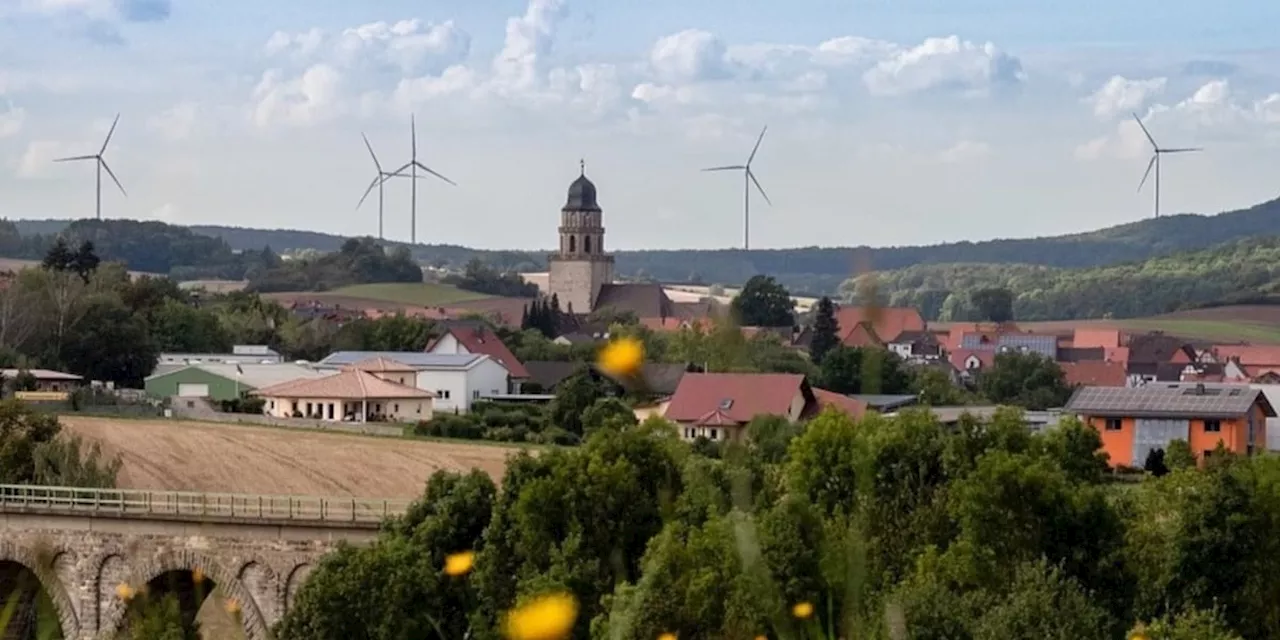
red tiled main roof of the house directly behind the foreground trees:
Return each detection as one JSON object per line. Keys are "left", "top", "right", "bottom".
{"left": 666, "top": 374, "right": 808, "bottom": 422}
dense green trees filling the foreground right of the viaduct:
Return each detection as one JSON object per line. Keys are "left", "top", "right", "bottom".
{"left": 276, "top": 401, "right": 1280, "bottom": 640}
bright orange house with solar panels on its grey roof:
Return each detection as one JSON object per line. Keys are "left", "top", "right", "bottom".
{"left": 1065, "top": 384, "right": 1276, "bottom": 468}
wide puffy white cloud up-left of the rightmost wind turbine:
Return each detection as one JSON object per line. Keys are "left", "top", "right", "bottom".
{"left": 863, "top": 36, "right": 1023, "bottom": 96}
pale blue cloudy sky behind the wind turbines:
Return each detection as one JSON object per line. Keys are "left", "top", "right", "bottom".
{"left": 0, "top": 0, "right": 1280, "bottom": 250}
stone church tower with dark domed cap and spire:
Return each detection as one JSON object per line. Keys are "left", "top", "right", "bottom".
{"left": 547, "top": 161, "right": 613, "bottom": 314}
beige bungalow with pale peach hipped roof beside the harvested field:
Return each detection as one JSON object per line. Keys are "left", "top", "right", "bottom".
{"left": 253, "top": 369, "right": 434, "bottom": 422}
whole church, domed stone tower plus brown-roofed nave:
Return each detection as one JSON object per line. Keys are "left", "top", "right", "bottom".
{"left": 544, "top": 165, "right": 705, "bottom": 325}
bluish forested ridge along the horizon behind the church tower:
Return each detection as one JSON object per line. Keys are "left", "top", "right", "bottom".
{"left": 14, "top": 198, "right": 1280, "bottom": 293}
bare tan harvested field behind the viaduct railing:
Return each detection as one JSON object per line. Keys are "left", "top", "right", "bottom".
{"left": 60, "top": 416, "right": 520, "bottom": 498}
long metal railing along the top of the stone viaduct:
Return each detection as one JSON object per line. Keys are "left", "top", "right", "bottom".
{"left": 0, "top": 485, "right": 410, "bottom": 524}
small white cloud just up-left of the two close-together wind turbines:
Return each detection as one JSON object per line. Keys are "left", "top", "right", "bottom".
{"left": 252, "top": 64, "right": 343, "bottom": 127}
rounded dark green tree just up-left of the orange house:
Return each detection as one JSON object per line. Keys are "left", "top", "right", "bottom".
{"left": 978, "top": 351, "right": 1071, "bottom": 411}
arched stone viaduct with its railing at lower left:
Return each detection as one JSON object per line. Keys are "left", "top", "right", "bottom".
{"left": 0, "top": 485, "right": 408, "bottom": 640}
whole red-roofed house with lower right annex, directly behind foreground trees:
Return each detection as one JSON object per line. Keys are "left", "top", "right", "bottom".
{"left": 664, "top": 374, "right": 867, "bottom": 442}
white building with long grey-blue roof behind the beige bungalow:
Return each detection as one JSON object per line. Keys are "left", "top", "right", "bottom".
{"left": 316, "top": 351, "right": 509, "bottom": 413}
